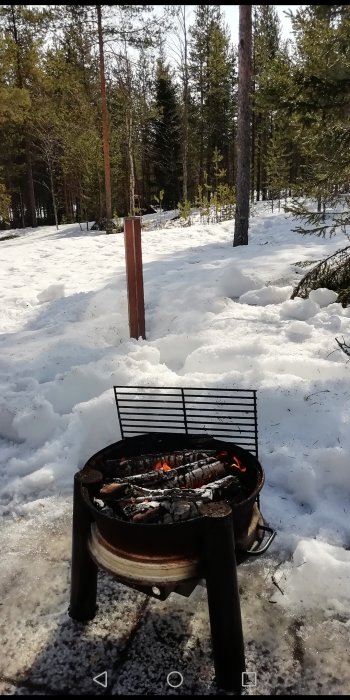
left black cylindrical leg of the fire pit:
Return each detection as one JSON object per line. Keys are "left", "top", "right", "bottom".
{"left": 69, "top": 473, "right": 97, "bottom": 622}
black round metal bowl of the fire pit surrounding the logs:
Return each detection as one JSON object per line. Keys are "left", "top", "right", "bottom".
{"left": 79, "top": 433, "right": 265, "bottom": 557}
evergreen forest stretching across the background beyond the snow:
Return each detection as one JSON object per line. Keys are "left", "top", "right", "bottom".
{"left": 0, "top": 5, "right": 350, "bottom": 234}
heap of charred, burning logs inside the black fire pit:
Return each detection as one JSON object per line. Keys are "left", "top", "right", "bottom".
{"left": 96, "top": 450, "right": 248, "bottom": 523}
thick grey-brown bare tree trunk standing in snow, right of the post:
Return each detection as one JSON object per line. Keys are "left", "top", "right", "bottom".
{"left": 233, "top": 5, "right": 252, "bottom": 246}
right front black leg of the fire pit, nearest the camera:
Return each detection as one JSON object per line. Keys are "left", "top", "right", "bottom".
{"left": 204, "top": 503, "right": 245, "bottom": 691}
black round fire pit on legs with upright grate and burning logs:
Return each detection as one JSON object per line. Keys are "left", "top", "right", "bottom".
{"left": 70, "top": 387, "right": 275, "bottom": 690}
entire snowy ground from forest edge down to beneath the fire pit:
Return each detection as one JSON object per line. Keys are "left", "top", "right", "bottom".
{"left": 0, "top": 205, "right": 350, "bottom": 694}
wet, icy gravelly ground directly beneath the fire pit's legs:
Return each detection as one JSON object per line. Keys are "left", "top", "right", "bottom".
{"left": 0, "top": 497, "right": 350, "bottom": 695}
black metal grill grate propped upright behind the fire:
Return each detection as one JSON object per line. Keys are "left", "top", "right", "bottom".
{"left": 113, "top": 386, "right": 258, "bottom": 457}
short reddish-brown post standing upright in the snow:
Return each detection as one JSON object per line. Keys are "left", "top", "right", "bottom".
{"left": 124, "top": 216, "right": 146, "bottom": 339}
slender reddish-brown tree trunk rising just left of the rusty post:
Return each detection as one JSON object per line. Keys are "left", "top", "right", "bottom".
{"left": 96, "top": 5, "right": 112, "bottom": 233}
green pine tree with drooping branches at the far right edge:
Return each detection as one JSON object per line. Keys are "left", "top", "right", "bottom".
{"left": 286, "top": 5, "right": 350, "bottom": 235}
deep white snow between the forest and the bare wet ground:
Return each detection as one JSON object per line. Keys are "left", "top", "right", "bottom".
{"left": 0, "top": 205, "right": 350, "bottom": 696}
